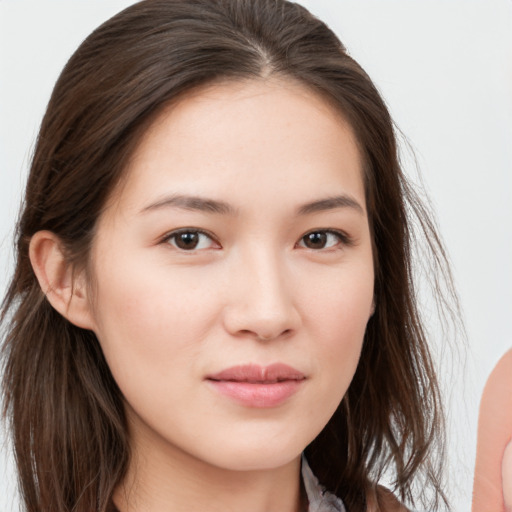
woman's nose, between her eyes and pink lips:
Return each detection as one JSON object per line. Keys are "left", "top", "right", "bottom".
{"left": 223, "top": 247, "right": 301, "bottom": 341}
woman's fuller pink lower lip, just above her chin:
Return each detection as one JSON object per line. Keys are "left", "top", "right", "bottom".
{"left": 208, "top": 380, "right": 303, "bottom": 409}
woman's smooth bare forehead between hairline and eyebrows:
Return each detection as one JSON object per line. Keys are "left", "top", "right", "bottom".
{"left": 110, "top": 78, "right": 364, "bottom": 214}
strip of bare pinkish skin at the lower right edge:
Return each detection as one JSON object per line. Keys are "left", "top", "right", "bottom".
{"left": 472, "top": 350, "right": 512, "bottom": 512}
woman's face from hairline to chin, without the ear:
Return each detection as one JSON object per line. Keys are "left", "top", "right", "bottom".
{"left": 86, "top": 79, "right": 374, "bottom": 470}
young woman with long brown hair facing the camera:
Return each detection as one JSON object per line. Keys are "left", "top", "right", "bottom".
{"left": 3, "top": 0, "right": 452, "bottom": 512}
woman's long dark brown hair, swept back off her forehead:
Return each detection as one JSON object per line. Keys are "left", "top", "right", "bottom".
{"left": 2, "top": 0, "right": 452, "bottom": 512}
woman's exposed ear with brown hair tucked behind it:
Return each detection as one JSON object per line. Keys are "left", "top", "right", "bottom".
{"left": 29, "top": 231, "right": 94, "bottom": 330}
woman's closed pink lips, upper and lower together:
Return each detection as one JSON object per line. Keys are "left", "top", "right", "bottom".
{"left": 206, "top": 363, "right": 306, "bottom": 408}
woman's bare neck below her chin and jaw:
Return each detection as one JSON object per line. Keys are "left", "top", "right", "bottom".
{"left": 114, "top": 426, "right": 307, "bottom": 512}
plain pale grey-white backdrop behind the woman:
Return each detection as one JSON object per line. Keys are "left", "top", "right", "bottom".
{"left": 0, "top": 0, "right": 512, "bottom": 512}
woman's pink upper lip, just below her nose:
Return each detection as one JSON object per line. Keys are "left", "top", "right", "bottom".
{"left": 207, "top": 363, "right": 306, "bottom": 384}
